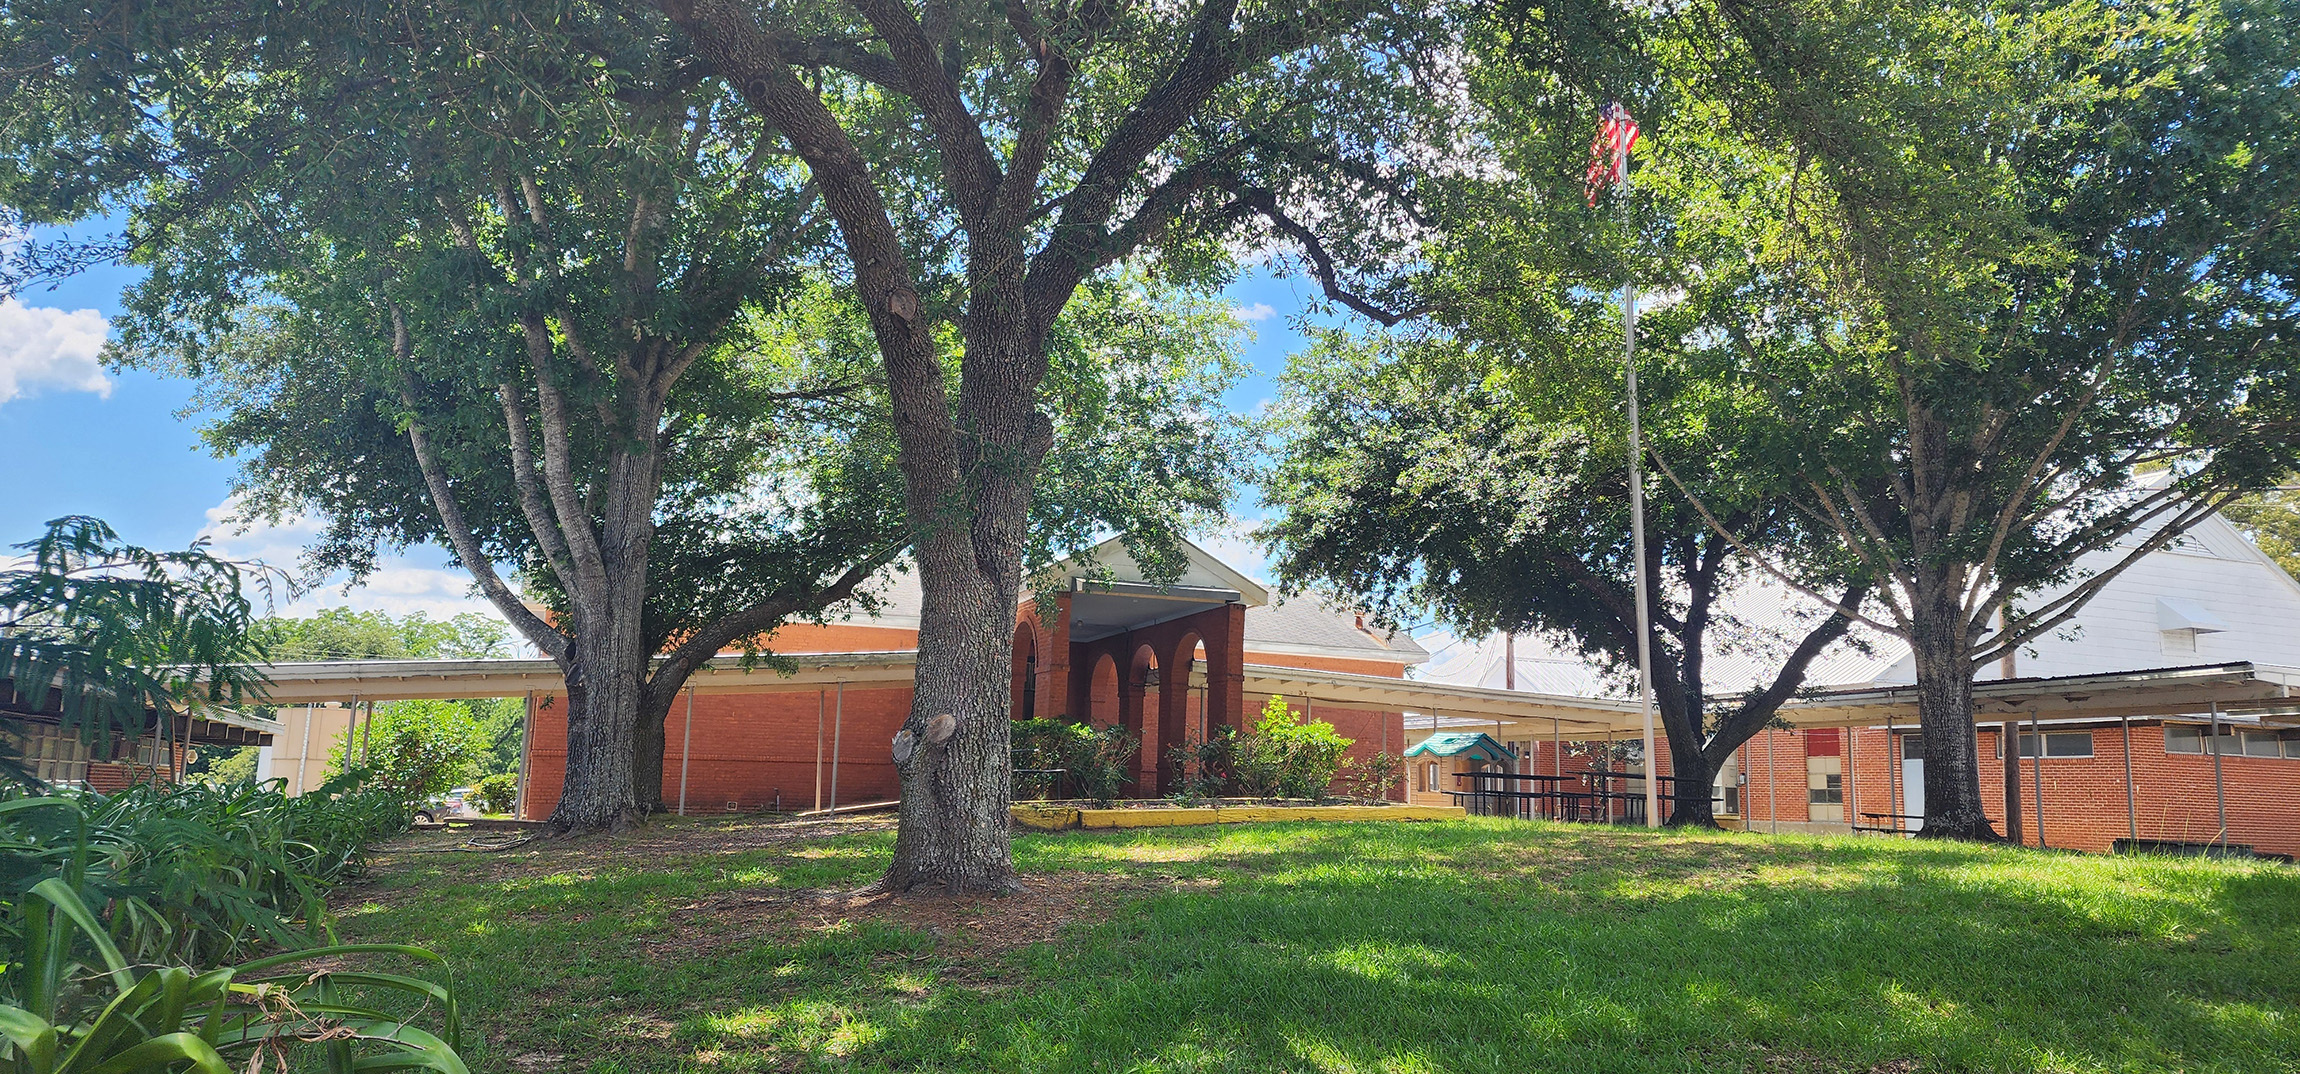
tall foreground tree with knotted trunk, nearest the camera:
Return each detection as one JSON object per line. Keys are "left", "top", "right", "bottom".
{"left": 639, "top": 0, "right": 1454, "bottom": 890}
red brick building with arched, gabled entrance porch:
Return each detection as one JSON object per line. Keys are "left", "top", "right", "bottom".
{"left": 522, "top": 540, "right": 1426, "bottom": 816}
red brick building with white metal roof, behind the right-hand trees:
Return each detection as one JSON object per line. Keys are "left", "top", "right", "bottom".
{"left": 1421, "top": 501, "right": 2300, "bottom": 856}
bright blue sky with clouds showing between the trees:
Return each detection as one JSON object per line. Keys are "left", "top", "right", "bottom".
{"left": 0, "top": 247, "right": 1343, "bottom": 614}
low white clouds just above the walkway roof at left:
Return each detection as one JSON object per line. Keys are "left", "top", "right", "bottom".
{"left": 200, "top": 497, "right": 504, "bottom": 619}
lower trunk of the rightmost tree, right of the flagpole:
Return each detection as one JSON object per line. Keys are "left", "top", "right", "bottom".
{"left": 1909, "top": 598, "right": 1996, "bottom": 839}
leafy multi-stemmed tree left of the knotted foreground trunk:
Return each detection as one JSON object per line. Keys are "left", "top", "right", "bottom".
{"left": 0, "top": 2, "right": 1260, "bottom": 830}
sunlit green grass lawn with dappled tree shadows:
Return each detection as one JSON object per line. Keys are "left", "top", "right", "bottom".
{"left": 343, "top": 821, "right": 2300, "bottom": 1074}
